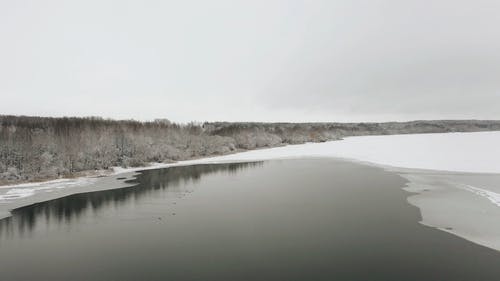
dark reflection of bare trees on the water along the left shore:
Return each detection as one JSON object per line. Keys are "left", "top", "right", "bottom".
{"left": 0, "top": 162, "right": 262, "bottom": 236}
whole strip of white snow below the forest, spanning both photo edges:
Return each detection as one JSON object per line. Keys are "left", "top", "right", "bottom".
{"left": 0, "top": 131, "right": 500, "bottom": 204}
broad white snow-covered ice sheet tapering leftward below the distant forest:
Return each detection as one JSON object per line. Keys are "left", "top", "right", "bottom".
{"left": 186, "top": 132, "right": 500, "bottom": 173}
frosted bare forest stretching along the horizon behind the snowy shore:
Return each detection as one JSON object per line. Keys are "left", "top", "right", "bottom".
{"left": 0, "top": 115, "right": 500, "bottom": 184}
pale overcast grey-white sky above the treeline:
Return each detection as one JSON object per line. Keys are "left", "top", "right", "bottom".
{"left": 0, "top": 0, "right": 500, "bottom": 122}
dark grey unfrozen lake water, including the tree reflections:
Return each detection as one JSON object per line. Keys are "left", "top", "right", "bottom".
{"left": 0, "top": 160, "right": 500, "bottom": 281}
